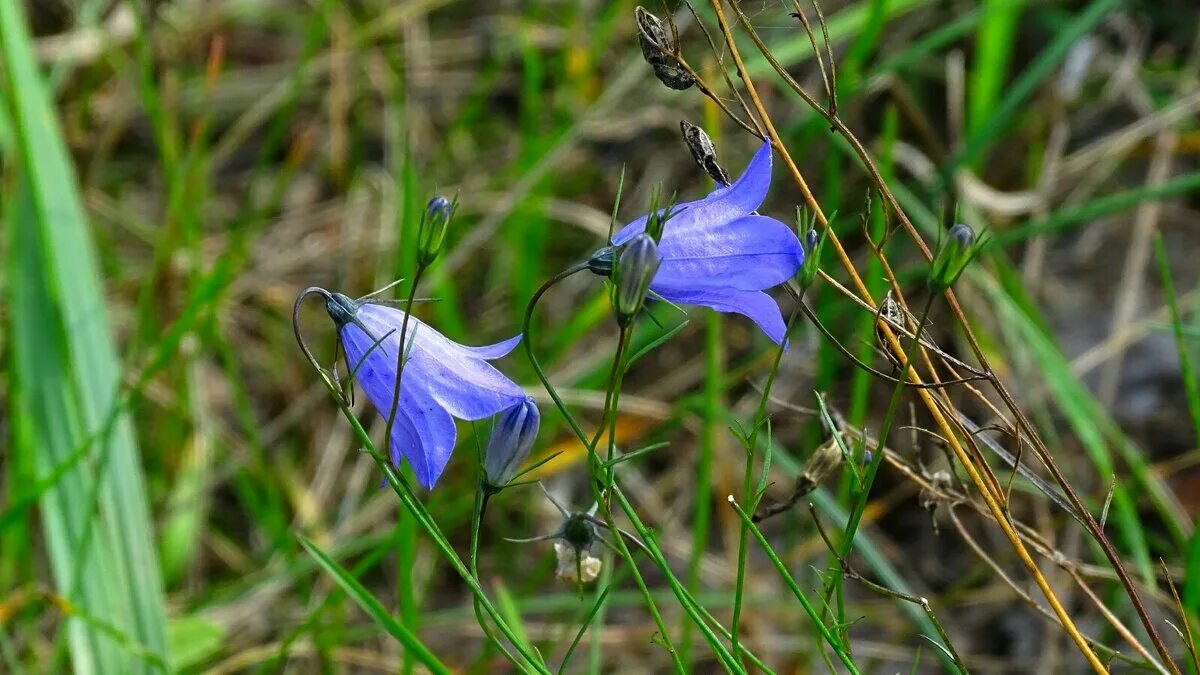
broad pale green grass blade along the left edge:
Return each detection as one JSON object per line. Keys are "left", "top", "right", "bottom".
{"left": 0, "top": 0, "right": 167, "bottom": 674}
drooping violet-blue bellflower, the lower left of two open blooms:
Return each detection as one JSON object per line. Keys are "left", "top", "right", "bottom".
{"left": 325, "top": 293, "right": 527, "bottom": 488}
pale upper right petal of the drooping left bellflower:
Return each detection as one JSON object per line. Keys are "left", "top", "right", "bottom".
{"left": 343, "top": 304, "right": 526, "bottom": 419}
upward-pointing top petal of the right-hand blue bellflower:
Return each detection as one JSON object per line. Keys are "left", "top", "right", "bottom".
{"left": 612, "top": 141, "right": 770, "bottom": 246}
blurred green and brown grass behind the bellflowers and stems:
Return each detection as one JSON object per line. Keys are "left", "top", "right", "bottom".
{"left": 0, "top": 0, "right": 1200, "bottom": 673}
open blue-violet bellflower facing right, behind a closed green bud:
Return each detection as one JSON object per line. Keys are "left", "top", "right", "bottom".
{"left": 609, "top": 142, "right": 804, "bottom": 344}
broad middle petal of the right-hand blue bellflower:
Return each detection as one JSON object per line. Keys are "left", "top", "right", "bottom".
{"left": 650, "top": 215, "right": 804, "bottom": 293}
